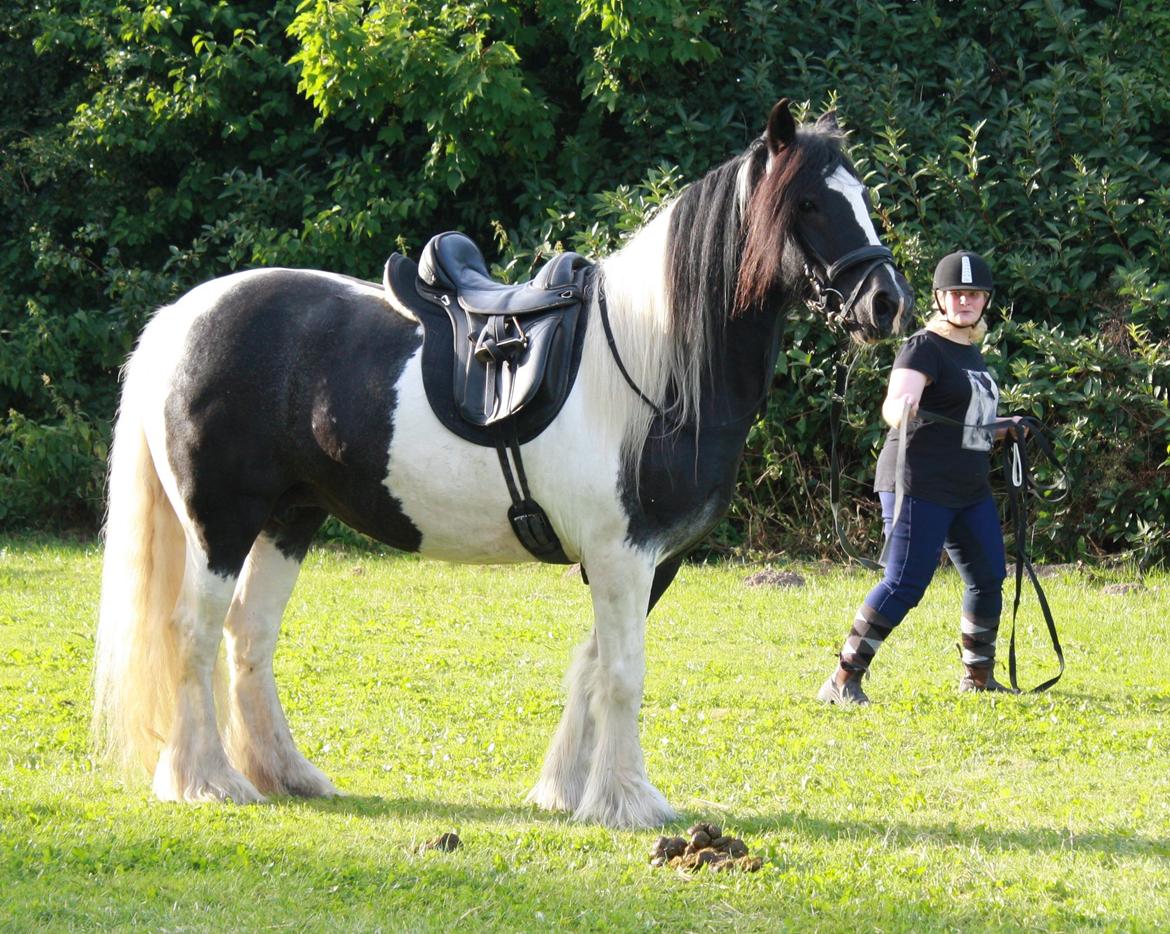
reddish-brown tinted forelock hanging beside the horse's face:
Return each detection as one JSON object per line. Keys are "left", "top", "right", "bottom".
{"left": 732, "top": 129, "right": 848, "bottom": 315}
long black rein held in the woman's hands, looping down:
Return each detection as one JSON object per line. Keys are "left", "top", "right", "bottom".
{"left": 830, "top": 360, "right": 1067, "bottom": 694}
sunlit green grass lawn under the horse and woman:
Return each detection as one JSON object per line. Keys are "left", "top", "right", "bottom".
{"left": 0, "top": 537, "right": 1170, "bottom": 932}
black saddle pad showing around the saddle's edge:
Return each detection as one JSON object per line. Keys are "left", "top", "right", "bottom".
{"left": 384, "top": 253, "right": 589, "bottom": 447}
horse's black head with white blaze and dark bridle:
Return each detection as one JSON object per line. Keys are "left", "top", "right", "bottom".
{"left": 736, "top": 99, "right": 914, "bottom": 343}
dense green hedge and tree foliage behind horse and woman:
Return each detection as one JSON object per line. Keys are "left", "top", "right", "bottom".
{"left": 0, "top": 0, "right": 1170, "bottom": 561}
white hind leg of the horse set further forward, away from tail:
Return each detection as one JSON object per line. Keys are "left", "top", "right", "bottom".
{"left": 225, "top": 509, "right": 337, "bottom": 797}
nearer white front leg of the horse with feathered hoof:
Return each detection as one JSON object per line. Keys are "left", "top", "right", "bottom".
{"left": 573, "top": 549, "right": 674, "bottom": 826}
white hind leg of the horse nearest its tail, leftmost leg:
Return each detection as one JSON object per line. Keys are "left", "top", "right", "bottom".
{"left": 146, "top": 534, "right": 264, "bottom": 804}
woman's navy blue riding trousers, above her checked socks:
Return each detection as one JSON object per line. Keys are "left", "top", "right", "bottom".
{"left": 865, "top": 493, "right": 1006, "bottom": 627}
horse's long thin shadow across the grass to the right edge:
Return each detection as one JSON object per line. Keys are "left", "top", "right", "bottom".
{"left": 273, "top": 795, "right": 1170, "bottom": 858}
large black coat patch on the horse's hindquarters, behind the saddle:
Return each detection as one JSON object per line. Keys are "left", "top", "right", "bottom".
{"left": 165, "top": 270, "right": 421, "bottom": 576}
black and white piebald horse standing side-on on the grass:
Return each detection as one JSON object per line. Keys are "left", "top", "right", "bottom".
{"left": 92, "top": 99, "right": 913, "bottom": 827}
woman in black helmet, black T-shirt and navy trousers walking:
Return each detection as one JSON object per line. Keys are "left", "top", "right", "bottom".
{"left": 818, "top": 250, "right": 1011, "bottom": 703}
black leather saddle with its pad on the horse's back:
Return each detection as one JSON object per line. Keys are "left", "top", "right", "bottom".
{"left": 383, "top": 232, "right": 593, "bottom": 447}
